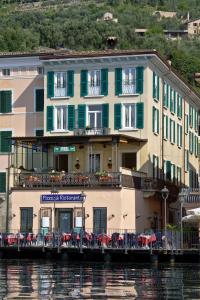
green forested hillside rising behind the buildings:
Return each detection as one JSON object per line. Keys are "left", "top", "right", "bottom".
{"left": 0, "top": 0, "right": 200, "bottom": 89}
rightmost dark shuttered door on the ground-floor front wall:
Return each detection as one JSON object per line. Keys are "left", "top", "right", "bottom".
{"left": 93, "top": 207, "right": 107, "bottom": 234}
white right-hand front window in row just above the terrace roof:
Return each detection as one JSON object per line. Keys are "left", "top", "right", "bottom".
{"left": 122, "top": 104, "right": 137, "bottom": 128}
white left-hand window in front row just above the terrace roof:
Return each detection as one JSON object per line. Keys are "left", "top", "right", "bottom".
{"left": 54, "top": 106, "right": 68, "bottom": 131}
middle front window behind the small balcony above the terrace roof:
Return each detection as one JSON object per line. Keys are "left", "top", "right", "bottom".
{"left": 87, "top": 105, "right": 102, "bottom": 129}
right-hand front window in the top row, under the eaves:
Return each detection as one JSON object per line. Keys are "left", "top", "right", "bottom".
{"left": 122, "top": 68, "right": 136, "bottom": 94}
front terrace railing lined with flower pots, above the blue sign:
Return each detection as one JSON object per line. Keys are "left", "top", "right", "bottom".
{"left": 14, "top": 172, "right": 121, "bottom": 188}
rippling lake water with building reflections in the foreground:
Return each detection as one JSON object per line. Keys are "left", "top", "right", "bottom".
{"left": 0, "top": 260, "right": 200, "bottom": 300}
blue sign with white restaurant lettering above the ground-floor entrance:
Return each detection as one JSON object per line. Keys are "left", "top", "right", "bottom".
{"left": 40, "top": 194, "right": 82, "bottom": 202}
